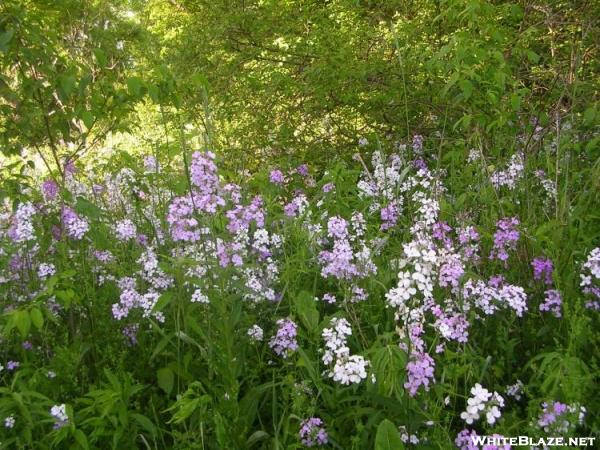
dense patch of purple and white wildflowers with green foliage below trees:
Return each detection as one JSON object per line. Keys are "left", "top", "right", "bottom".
{"left": 0, "top": 124, "right": 600, "bottom": 449}
